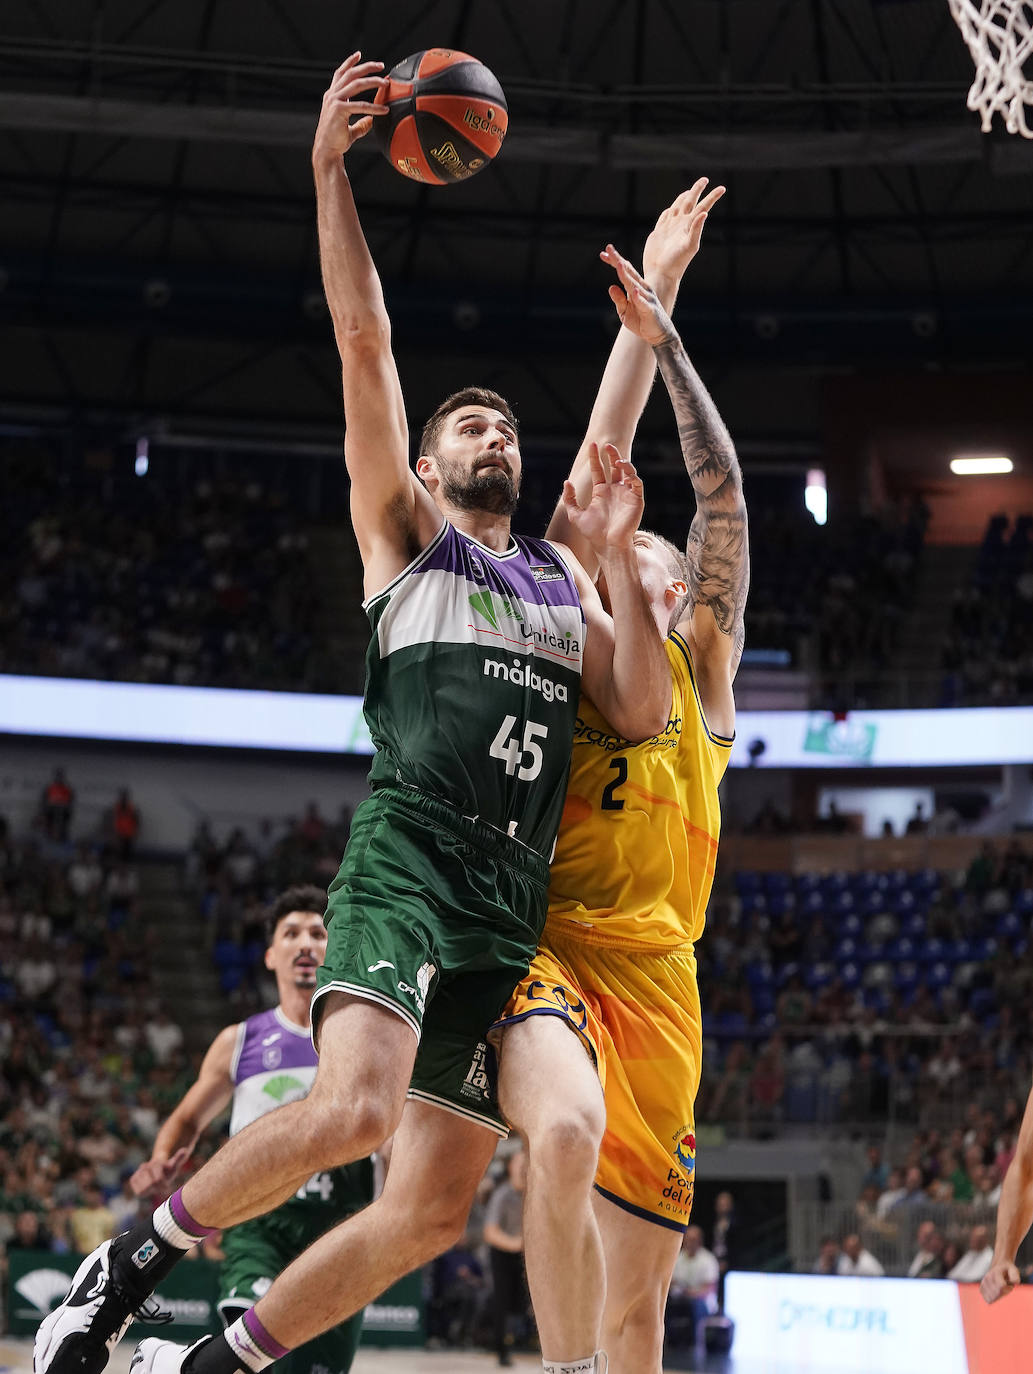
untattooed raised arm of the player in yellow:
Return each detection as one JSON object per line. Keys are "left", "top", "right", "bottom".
{"left": 548, "top": 177, "right": 724, "bottom": 576}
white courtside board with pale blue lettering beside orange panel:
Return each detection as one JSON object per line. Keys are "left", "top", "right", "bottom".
{"left": 724, "top": 1272, "right": 967, "bottom": 1374}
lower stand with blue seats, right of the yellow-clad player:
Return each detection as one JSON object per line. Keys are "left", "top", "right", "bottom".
{"left": 698, "top": 840, "right": 1033, "bottom": 1134}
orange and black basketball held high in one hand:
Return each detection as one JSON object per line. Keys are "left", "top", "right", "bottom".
{"left": 374, "top": 48, "right": 510, "bottom": 185}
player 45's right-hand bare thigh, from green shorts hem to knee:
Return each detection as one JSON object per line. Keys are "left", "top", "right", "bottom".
{"left": 375, "top": 1098, "right": 499, "bottom": 1249}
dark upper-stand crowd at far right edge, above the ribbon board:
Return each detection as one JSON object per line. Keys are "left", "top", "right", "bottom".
{"left": 940, "top": 514, "right": 1033, "bottom": 706}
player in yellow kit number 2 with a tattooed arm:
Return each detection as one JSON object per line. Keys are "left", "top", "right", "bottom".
{"left": 497, "top": 181, "right": 749, "bottom": 1374}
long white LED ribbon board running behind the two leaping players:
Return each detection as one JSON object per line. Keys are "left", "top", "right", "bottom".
{"left": 0, "top": 675, "right": 1033, "bottom": 768}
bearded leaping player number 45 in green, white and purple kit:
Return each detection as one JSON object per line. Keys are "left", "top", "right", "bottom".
{"left": 36, "top": 54, "right": 672, "bottom": 1374}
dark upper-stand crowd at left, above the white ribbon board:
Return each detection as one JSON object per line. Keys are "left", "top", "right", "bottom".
{"left": 0, "top": 441, "right": 326, "bottom": 691}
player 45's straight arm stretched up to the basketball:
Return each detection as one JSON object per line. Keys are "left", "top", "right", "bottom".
{"left": 312, "top": 52, "right": 441, "bottom": 595}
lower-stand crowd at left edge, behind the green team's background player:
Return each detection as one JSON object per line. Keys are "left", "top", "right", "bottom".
{"left": 0, "top": 818, "right": 192, "bottom": 1291}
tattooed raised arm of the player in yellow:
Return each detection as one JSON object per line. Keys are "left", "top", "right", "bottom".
{"left": 610, "top": 254, "right": 750, "bottom": 728}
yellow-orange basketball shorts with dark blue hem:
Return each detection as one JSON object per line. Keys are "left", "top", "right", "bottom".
{"left": 492, "top": 926, "right": 702, "bottom": 1231}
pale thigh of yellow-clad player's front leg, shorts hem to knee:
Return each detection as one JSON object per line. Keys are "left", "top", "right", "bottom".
{"left": 499, "top": 1013, "right": 606, "bottom": 1137}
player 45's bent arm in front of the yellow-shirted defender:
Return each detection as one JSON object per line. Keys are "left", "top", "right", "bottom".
{"left": 563, "top": 444, "right": 672, "bottom": 742}
